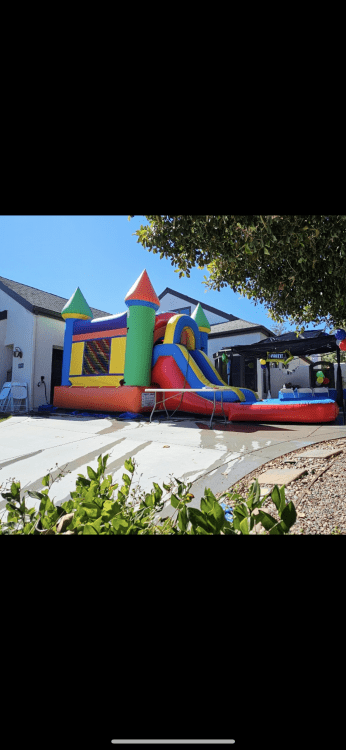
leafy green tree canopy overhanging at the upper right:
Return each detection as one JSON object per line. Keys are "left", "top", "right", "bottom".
{"left": 129, "top": 215, "right": 346, "bottom": 329}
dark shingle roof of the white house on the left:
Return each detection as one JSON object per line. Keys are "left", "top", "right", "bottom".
{"left": 0, "top": 276, "right": 111, "bottom": 320}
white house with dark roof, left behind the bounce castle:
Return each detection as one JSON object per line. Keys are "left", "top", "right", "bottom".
{"left": 0, "top": 276, "right": 110, "bottom": 410}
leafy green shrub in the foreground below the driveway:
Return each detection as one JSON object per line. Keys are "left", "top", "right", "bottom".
{"left": 0, "top": 455, "right": 296, "bottom": 536}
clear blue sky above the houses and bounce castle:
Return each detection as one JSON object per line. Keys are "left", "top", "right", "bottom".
{"left": 0, "top": 216, "right": 322, "bottom": 329}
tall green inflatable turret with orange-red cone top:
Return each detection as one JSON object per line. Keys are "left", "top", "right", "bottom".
{"left": 124, "top": 270, "right": 160, "bottom": 387}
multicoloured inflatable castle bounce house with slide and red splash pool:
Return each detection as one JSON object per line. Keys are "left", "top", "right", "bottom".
{"left": 54, "top": 270, "right": 338, "bottom": 422}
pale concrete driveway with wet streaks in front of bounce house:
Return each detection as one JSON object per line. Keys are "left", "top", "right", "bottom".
{"left": 0, "top": 414, "right": 346, "bottom": 519}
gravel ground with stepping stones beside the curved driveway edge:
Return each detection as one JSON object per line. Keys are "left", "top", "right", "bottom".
{"left": 218, "top": 438, "right": 346, "bottom": 535}
